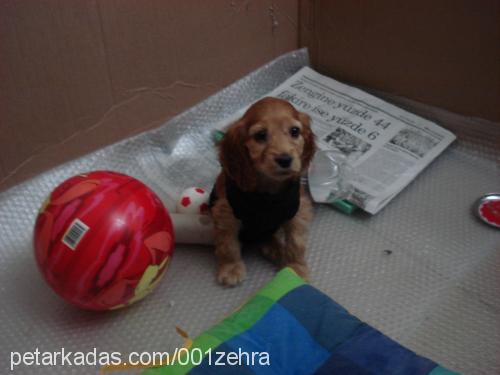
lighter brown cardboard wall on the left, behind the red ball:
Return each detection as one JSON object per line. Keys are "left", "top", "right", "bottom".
{"left": 0, "top": 0, "right": 298, "bottom": 189}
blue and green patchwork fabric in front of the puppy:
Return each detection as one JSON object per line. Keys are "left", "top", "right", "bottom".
{"left": 145, "top": 268, "right": 455, "bottom": 375}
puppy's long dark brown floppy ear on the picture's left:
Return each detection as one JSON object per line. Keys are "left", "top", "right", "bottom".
{"left": 219, "top": 118, "right": 256, "bottom": 191}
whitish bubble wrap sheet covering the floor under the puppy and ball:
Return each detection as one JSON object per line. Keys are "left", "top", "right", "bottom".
{"left": 0, "top": 50, "right": 500, "bottom": 374}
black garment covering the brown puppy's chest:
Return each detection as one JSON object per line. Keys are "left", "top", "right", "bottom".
{"left": 209, "top": 176, "right": 300, "bottom": 243}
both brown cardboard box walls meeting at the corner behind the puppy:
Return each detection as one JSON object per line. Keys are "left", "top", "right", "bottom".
{"left": 0, "top": 0, "right": 500, "bottom": 190}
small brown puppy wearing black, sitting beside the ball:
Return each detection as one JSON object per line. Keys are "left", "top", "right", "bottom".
{"left": 211, "top": 97, "right": 316, "bottom": 286}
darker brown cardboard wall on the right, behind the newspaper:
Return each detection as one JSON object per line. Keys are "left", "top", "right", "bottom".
{"left": 300, "top": 0, "right": 500, "bottom": 122}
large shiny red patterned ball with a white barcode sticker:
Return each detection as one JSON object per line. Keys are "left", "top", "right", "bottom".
{"left": 34, "top": 171, "right": 174, "bottom": 310}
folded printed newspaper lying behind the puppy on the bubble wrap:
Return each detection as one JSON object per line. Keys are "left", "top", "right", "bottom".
{"left": 218, "top": 67, "right": 456, "bottom": 214}
